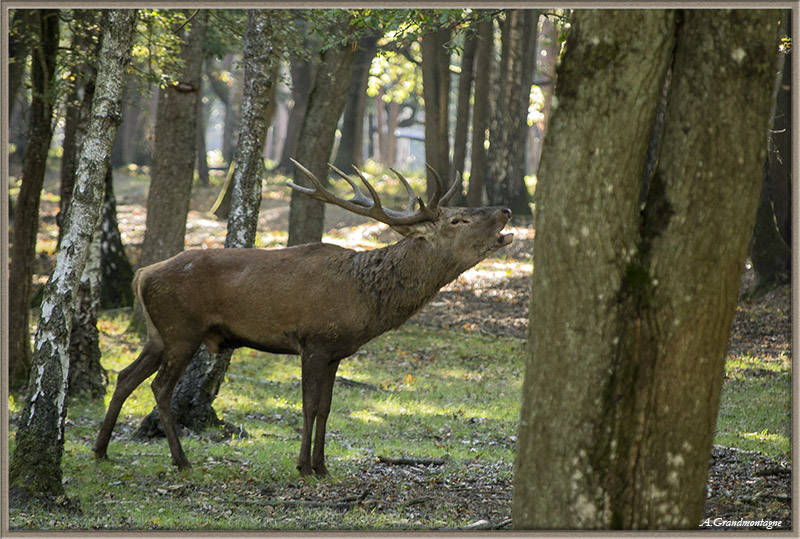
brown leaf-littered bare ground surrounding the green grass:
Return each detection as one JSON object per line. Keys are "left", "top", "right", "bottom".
{"left": 12, "top": 172, "right": 792, "bottom": 530}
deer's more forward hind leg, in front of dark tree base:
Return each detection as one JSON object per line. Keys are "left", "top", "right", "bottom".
{"left": 151, "top": 344, "right": 199, "bottom": 470}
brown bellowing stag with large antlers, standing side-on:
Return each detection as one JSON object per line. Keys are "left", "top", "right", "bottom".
{"left": 94, "top": 160, "right": 514, "bottom": 476}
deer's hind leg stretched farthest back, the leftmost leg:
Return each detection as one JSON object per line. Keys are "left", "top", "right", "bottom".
{"left": 94, "top": 339, "right": 164, "bottom": 459}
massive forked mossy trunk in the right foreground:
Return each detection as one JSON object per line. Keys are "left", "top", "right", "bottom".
{"left": 513, "top": 10, "right": 778, "bottom": 529}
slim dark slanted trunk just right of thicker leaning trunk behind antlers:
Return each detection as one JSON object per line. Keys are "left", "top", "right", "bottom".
{"left": 334, "top": 35, "right": 380, "bottom": 170}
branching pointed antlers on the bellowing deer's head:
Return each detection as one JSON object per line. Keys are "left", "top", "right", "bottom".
{"left": 286, "top": 159, "right": 458, "bottom": 226}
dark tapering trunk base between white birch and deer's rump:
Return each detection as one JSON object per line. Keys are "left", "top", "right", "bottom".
{"left": 100, "top": 167, "right": 133, "bottom": 309}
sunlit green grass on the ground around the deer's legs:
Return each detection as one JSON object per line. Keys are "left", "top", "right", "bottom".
{"left": 9, "top": 304, "right": 791, "bottom": 530}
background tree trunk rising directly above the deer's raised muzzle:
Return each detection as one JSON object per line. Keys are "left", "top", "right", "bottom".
{"left": 486, "top": 9, "right": 539, "bottom": 221}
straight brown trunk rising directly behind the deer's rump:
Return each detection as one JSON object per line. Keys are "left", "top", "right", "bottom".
{"left": 140, "top": 10, "right": 208, "bottom": 266}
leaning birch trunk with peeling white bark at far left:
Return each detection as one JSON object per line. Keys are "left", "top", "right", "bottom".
{"left": 8, "top": 9, "right": 137, "bottom": 507}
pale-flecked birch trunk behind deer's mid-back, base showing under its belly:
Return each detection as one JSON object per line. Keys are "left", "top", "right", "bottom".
{"left": 137, "top": 10, "right": 285, "bottom": 437}
